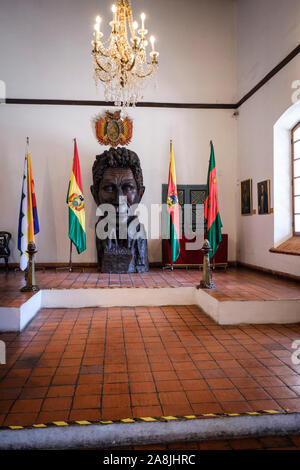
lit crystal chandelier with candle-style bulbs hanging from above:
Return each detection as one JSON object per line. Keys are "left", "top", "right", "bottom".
{"left": 92, "top": 0, "right": 159, "bottom": 106}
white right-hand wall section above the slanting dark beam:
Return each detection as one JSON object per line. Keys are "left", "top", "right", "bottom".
{"left": 237, "top": 0, "right": 300, "bottom": 99}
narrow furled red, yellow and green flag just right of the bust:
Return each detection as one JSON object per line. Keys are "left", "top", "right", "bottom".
{"left": 167, "top": 141, "right": 180, "bottom": 263}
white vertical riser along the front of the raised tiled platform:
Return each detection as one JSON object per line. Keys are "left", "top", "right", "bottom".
{"left": 0, "top": 287, "right": 300, "bottom": 332}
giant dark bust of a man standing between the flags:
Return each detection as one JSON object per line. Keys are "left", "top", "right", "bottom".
{"left": 91, "top": 147, "right": 149, "bottom": 273}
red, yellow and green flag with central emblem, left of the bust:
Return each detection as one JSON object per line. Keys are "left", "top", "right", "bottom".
{"left": 67, "top": 139, "right": 86, "bottom": 254}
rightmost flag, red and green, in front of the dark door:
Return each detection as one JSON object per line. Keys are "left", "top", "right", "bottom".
{"left": 204, "top": 141, "right": 222, "bottom": 258}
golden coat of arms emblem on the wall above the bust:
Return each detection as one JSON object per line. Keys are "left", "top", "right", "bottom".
{"left": 96, "top": 111, "right": 132, "bottom": 147}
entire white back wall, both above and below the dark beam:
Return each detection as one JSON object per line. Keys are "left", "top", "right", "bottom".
{"left": 0, "top": 0, "right": 236, "bottom": 262}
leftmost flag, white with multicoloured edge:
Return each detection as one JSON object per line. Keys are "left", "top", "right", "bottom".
{"left": 18, "top": 140, "right": 40, "bottom": 271}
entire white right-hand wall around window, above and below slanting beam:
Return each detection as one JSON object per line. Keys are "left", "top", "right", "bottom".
{"left": 236, "top": 0, "right": 300, "bottom": 275}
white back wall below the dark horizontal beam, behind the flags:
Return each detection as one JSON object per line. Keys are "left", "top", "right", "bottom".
{"left": 0, "top": 105, "right": 236, "bottom": 262}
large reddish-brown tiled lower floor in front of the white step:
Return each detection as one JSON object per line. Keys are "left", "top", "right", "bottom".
{"left": 0, "top": 306, "right": 300, "bottom": 426}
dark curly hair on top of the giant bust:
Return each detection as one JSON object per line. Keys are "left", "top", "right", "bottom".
{"left": 91, "top": 147, "right": 143, "bottom": 200}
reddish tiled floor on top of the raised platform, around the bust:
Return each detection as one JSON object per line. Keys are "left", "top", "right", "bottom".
{"left": 0, "top": 267, "right": 300, "bottom": 307}
